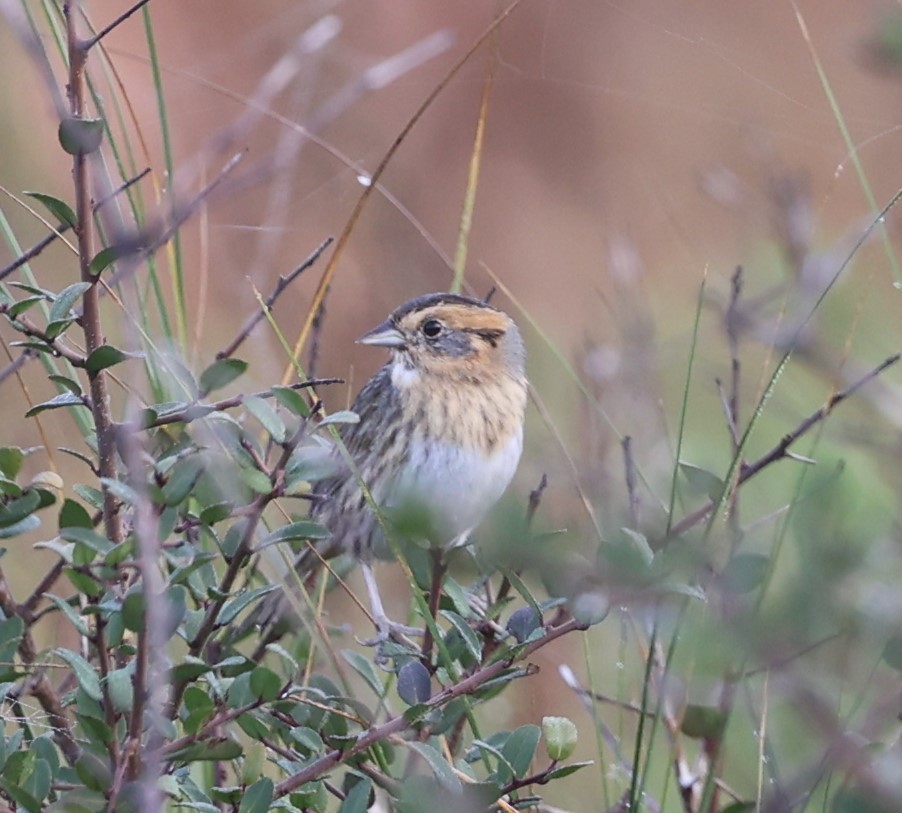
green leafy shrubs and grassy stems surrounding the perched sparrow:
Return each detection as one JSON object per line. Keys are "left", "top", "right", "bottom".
{"left": 0, "top": 1, "right": 902, "bottom": 813}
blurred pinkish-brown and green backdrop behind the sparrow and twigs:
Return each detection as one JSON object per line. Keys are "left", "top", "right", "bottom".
{"left": 0, "top": 0, "right": 902, "bottom": 809}
